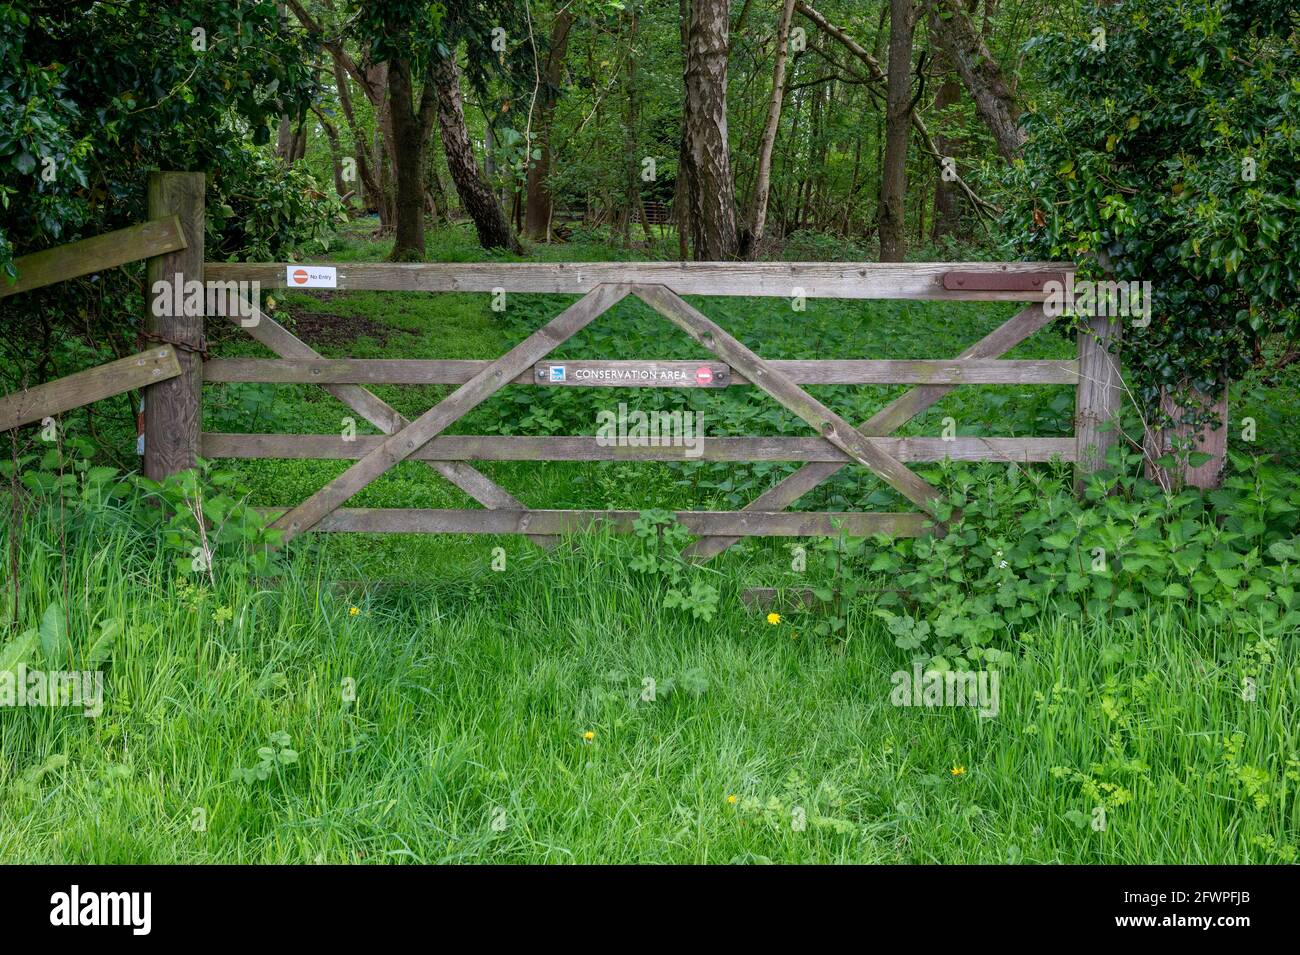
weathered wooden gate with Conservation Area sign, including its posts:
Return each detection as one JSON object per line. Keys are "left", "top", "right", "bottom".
{"left": 4, "top": 173, "right": 1121, "bottom": 559}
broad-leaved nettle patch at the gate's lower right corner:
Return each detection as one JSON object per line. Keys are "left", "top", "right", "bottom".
{"left": 815, "top": 457, "right": 1300, "bottom": 669}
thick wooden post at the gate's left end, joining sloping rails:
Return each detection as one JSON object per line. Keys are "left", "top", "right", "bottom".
{"left": 144, "top": 173, "right": 207, "bottom": 481}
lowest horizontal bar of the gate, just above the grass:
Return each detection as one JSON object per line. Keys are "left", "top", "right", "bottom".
{"left": 257, "top": 508, "right": 931, "bottom": 537}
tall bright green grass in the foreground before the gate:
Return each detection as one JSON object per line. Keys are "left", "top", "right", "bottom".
{"left": 0, "top": 507, "right": 1300, "bottom": 863}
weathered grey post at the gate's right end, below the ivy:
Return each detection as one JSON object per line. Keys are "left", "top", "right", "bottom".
{"left": 1074, "top": 316, "right": 1123, "bottom": 494}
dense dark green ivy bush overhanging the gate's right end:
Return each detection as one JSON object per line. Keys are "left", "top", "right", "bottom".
{"left": 1000, "top": 0, "right": 1300, "bottom": 478}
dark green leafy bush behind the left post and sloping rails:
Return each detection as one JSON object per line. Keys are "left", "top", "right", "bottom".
{"left": 0, "top": 0, "right": 341, "bottom": 426}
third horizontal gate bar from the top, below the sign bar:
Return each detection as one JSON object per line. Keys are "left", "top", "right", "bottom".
{"left": 202, "top": 431, "right": 1078, "bottom": 464}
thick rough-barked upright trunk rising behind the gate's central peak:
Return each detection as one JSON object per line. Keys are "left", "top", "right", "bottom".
{"left": 685, "top": 0, "right": 738, "bottom": 261}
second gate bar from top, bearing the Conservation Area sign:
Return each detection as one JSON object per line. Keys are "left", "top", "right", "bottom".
{"left": 203, "top": 359, "right": 1079, "bottom": 387}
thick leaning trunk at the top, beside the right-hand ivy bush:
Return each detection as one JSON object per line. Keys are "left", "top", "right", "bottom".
{"left": 928, "top": 0, "right": 1024, "bottom": 162}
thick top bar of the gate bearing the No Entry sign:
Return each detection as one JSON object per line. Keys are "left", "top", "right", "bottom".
{"left": 203, "top": 262, "right": 1075, "bottom": 301}
